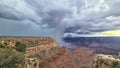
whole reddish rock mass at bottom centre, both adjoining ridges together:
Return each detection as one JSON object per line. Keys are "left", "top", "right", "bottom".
{"left": 29, "top": 46, "right": 95, "bottom": 68}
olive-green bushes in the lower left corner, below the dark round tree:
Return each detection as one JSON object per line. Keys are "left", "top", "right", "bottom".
{"left": 0, "top": 48, "right": 25, "bottom": 68}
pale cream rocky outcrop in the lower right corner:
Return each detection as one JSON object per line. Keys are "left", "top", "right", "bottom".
{"left": 93, "top": 54, "right": 120, "bottom": 68}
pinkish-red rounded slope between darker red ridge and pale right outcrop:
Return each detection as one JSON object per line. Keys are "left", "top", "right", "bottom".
{"left": 72, "top": 47, "right": 95, "bottom": 68}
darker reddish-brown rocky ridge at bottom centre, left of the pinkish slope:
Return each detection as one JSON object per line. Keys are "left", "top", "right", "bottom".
{"left": 39, "top": 47, "right": 79, "bottom": 68}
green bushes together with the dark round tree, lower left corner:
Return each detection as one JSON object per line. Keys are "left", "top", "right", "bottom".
{"left": 0, "top": 41, "right": 26, "bottom": 68}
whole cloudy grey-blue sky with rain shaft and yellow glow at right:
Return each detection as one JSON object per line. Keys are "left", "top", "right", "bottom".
{"left": 0, "top": 0, "right": 120, "bottom": 42}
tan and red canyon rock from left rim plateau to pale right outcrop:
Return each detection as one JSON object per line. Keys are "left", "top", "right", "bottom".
{"left": 0, "top": 37, "right": 120, "bottom": 68}
